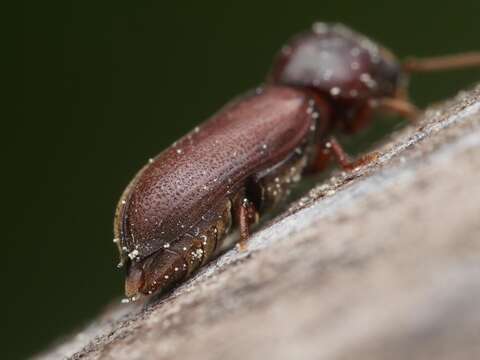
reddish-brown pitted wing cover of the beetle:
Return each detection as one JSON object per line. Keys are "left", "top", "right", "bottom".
{"left": 115, "top": 86, "right": 318, "bottom": 259}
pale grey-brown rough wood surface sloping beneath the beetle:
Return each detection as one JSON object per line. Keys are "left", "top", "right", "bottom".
{"left": 39, "top": 86, "right": 480, "bottom": 359}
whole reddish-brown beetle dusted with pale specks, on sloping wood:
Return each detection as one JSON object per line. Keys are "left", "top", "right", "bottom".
{"left": 114, "top": 23, "right": 480, "bottom": 302}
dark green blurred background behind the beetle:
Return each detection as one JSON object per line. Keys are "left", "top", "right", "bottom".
{"left": 10, "top": 0, "right": 480, "bottom": 359}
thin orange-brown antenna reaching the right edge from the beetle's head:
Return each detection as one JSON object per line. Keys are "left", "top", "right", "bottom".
{"left": 403, "top": 52, "right": 480, "bottom": 73}
